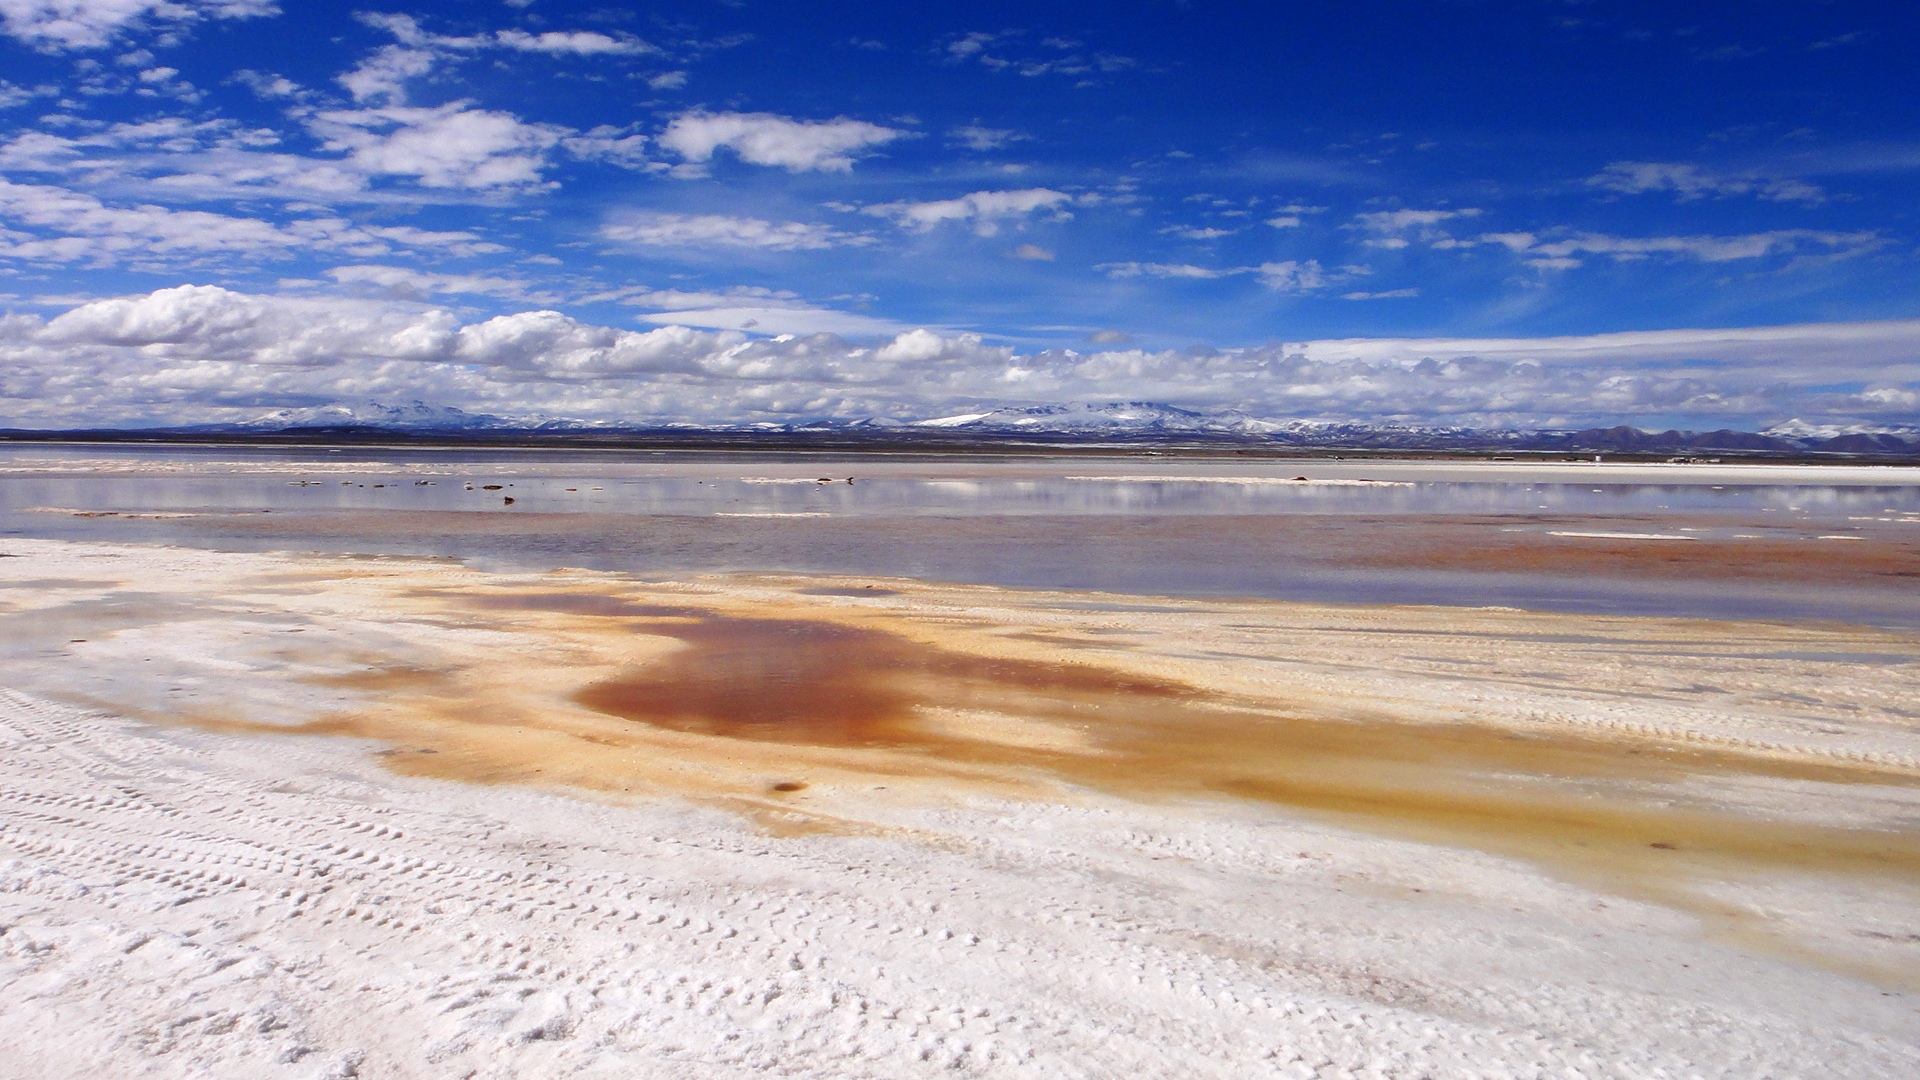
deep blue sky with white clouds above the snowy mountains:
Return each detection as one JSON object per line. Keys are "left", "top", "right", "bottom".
{"left": 0, "top": 0, "right": 1920, "bottom": 429}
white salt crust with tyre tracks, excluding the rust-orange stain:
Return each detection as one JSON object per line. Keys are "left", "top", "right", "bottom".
{"left": 0, "top": 542, "right": 1920, "bottom": 1078}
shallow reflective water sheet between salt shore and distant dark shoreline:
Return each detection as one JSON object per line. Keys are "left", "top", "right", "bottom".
{"left": 0, "top": 438, "right": 1920, "bottom": 626}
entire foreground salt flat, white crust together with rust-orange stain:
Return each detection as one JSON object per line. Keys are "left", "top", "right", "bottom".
{"left": 0, "top": 540, "right": 1920, "bottom": 1076}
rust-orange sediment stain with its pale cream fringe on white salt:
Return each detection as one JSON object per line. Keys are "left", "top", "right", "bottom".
{"left": 48, "top": 575, "right": 1920, "bottom": 986}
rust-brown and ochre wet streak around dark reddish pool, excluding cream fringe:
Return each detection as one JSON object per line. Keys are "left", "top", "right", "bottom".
{"left": 274, "top": 592, "right": 1920, "bottom": 895}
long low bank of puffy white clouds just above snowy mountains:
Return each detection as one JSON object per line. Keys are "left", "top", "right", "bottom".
{"left": 0, "top": 286, "right": 1920, "bottom": 427}
